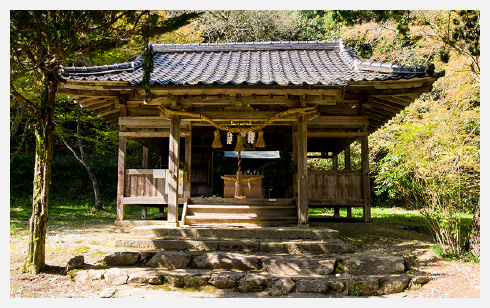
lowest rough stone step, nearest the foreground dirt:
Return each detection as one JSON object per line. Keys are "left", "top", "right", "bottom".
{"left": 69, "top": 267, "right": 415, "bottom": 297}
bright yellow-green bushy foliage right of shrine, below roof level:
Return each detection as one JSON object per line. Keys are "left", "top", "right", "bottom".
{"left": 372, "top": 58, "right": 480, "bottom": 255}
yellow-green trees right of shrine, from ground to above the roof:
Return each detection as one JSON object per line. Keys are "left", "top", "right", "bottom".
{"left": 332, "top": 11, "right": 480, "bottom": 255}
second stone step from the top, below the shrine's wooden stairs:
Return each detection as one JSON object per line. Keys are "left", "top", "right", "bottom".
{"left": 115, "top": 238, "right": 355, "bottom": 254}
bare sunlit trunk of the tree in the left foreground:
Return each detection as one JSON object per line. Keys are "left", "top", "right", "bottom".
{"left": 22, "top": 73, "right": 57, "bottom": 274}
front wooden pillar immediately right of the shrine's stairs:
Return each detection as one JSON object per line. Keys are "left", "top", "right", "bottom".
{"left": 296, "top": 114, "right": 308, "bottom": 227}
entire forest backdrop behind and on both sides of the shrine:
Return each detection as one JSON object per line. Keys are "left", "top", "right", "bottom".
{"left": 10, "top": 10, "right": 480, "bottom": 256}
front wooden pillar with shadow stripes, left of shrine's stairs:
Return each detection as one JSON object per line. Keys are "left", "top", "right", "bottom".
{"left": 166, "top": 115, "right": 180, "bottom": 227}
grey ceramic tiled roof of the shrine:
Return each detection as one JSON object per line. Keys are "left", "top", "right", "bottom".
{"left": 60, "top": 40, "right": 427, "bottom": 86}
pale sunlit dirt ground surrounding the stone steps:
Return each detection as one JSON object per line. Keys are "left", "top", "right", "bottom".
{"left": 10, "top": 223, "right": 480, "bottom": 298}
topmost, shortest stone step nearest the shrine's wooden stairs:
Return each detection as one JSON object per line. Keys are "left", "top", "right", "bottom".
{"left": 132, "top": 225, "right": 339, "bottom": 241}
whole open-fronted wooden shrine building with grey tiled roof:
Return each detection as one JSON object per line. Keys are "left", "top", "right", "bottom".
{"left": 60, "top": 41, "right": 443, "bottom": 226}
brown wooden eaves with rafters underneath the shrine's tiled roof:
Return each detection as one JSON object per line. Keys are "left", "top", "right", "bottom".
{"left": 59, "top": 73, "right": 441, "bottom": 133}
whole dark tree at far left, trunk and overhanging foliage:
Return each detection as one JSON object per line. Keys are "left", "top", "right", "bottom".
{"left": 10, "top": 10, "right": 198, "bottom": 273}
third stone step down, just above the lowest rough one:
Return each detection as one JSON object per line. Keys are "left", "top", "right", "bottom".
{"left": 97, "top": 250, "right": 406, "bottom": 276}
